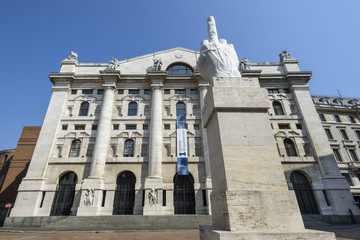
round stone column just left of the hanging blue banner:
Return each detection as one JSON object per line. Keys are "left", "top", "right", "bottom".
{"left": 143, "top": 71, "right": 166, "bottom": 215}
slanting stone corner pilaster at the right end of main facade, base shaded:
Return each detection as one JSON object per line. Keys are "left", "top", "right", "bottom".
{"left": 290, "top": 82, "right": 360, "bottom": 215}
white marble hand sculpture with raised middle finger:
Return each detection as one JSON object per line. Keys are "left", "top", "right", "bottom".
{"left": 197, "top": 16, "right": 241, "bottom": 81}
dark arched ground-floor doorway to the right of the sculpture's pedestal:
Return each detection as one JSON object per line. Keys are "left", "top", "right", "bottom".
{"left": 290, "top": 171, "right": 319, "bottom": 214}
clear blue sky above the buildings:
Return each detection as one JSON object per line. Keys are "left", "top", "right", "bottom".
{"left": 0, "top": 0, "right": 360, "bottom": 150}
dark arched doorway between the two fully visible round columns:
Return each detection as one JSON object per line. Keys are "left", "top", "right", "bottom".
{"left": 113, "top": 171, "right": 136, "bottom": 215}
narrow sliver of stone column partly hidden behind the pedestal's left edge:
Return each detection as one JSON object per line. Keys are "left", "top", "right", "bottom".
{"left": 199, "top": 83, "right": 212, "bottom": 215}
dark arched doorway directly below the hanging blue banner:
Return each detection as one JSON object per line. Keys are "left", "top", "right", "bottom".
{"left": 174, "top": 173, "right": 195, "bottom": 214}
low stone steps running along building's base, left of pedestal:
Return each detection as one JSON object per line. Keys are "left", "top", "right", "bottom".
{"left": 4, "top": 215, "right": 212, "bottom": 231}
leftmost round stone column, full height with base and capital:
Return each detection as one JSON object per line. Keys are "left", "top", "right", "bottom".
{"left": 77, "top": 71, "right": 120, "bottom": 216}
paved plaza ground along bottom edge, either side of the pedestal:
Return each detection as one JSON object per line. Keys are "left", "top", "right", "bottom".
{"left": 0, "top": 224, "right": 360, "bottom": 240}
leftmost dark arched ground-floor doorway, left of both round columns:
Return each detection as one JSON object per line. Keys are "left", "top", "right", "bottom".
{"left": 50, "top": 172, "right": 77, "bottom": 216}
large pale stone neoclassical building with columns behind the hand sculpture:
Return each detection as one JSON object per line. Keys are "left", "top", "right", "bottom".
{"left": 11, "top": 48, "right": 359, "bottom": 217}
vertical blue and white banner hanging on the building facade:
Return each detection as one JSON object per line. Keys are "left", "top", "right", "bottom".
{"left": 176, "top": 116, "right": 189, "bottom": 175}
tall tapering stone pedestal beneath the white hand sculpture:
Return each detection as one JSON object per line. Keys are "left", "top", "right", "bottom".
{"left": 200, "top": 77, "right": 335, "bottom": 239}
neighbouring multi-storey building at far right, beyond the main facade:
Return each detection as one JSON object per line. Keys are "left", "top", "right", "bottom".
{"left": 313, "top": 96, "right": 360, "bottom": 204}
